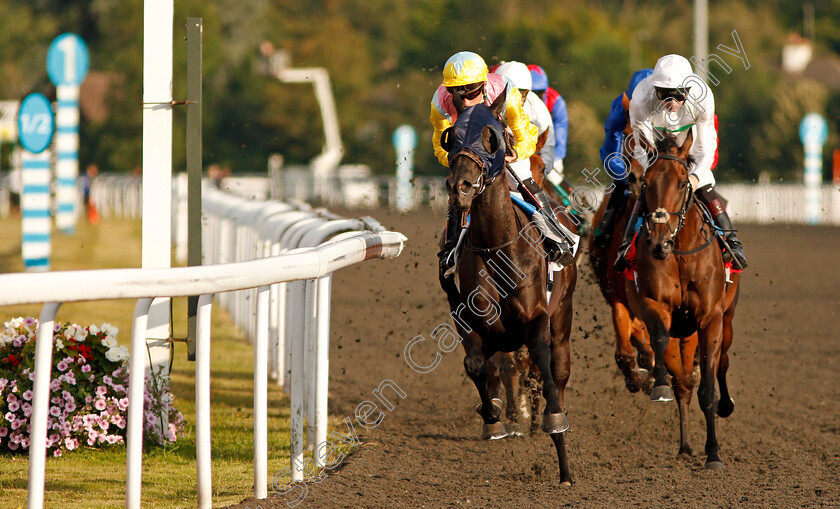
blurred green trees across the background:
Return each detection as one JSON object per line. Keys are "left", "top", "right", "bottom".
{"left": 0, "top": 0, "right": 840, "bottom": 181}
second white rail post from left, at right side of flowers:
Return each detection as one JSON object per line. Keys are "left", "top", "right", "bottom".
{"left": 125, "top": 299, "right": 152, "bottom": 509}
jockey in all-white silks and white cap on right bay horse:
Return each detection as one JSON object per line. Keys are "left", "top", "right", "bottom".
{"left": 615, "top": 55, "right": 747, "bottom": 272}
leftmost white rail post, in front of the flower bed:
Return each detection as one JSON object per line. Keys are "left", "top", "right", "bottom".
{"left": 26, "top": 302, "right": 61, "bottom": 509}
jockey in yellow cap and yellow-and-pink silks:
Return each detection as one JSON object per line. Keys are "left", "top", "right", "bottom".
{"left": 429, "top": 51, "right": 572, "bottom": 272}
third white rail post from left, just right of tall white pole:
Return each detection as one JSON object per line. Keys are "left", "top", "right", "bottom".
{"left": 195, "top": 295, "right": 213, "bottom": 509}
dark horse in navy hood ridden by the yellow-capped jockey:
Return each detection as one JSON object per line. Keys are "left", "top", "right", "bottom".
{"left": 440, "top": 92, "right": 577, "bottom": 484}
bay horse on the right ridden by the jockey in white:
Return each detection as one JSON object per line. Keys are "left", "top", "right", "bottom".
{"left": 627, "top": 132, "right": 739, "bottom": 469}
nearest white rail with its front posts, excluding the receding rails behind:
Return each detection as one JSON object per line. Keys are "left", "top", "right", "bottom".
{"left": 0, "top": 212, "right": 406, "bottom": 508}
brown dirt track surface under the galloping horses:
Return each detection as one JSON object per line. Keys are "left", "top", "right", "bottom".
{"left": 226, "top": 207, "right": 840, "bottom": 509}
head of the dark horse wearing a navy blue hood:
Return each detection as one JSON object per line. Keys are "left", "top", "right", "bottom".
{"left": 441, "top": 94, "right": 505, "bottom": 211}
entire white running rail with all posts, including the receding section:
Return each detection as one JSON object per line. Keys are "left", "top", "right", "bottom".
{"left": 0, "top": 188, "right": 406, "bottom": 508}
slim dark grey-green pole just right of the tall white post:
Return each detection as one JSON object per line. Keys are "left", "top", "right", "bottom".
{"left": 187, "top": 18, "right": 204, "bottom": 361}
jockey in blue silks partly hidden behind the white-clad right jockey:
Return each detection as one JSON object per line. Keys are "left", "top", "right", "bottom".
{"left": 593, "top": 69, "right": 653, "bottom": 247}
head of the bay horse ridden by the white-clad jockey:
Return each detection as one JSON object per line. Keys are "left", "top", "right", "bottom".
{"left": 643, "top": 131, "right": 693, "bottom": 260}
